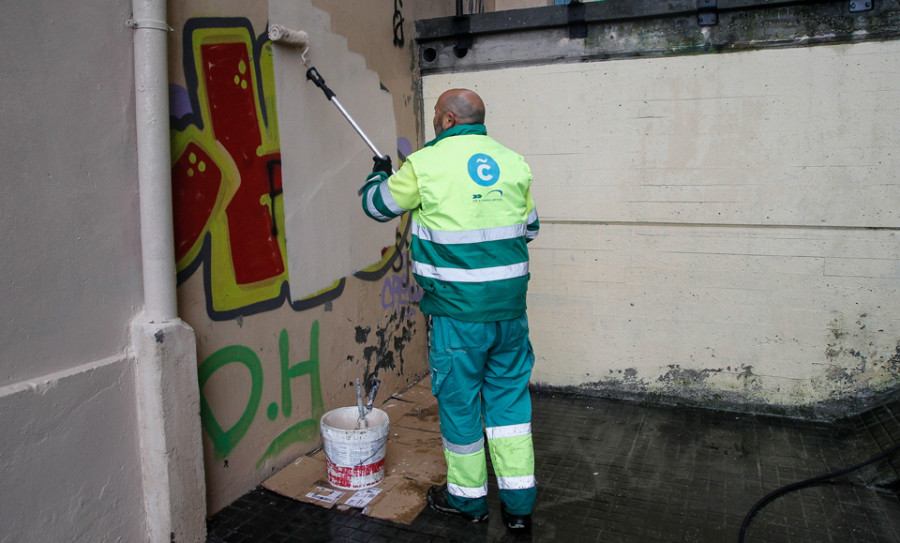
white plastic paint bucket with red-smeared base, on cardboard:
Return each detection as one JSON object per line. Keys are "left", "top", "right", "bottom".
{"left": 319, "top": 407, "right": 391, "bottom": 490}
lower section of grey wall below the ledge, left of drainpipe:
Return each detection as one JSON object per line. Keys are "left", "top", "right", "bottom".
{"left": 0, "top": 358, "right": 143, "bottom": 543}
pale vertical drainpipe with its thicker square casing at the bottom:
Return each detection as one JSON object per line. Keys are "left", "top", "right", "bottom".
{"left": 128, "top": 0, "right": 206, "bottom": 543}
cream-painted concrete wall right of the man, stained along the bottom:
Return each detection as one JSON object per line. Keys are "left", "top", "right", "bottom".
{"left": 423, "top": 41, "right": 900, "bottom": 412}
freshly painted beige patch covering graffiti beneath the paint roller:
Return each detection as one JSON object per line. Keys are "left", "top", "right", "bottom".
{"left": 269, "top": 0, "right": 397, "bottom": 300}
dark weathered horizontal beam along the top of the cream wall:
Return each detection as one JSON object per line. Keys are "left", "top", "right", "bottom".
{"left": 416, "top": 0, "right": 900, "bottom": 75}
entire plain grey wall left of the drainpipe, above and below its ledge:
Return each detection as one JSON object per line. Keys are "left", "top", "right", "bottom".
{"left": 0, "top": 0, "right": 143, "bottom": 542}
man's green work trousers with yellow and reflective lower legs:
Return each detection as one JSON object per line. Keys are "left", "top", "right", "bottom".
{"left": 429, "top": 315, "right": 537, "bottom": 516}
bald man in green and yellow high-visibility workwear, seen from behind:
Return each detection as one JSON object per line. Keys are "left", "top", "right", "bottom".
{"left": 361, "top": 89, "right": 539, "bottom": 531}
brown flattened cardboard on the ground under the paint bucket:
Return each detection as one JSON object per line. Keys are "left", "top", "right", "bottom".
{"left": 262, "top": 379, "right": 447, "bottom": 524}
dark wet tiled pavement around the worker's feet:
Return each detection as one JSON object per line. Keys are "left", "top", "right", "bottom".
{"left": 208, "top": 392, "right": 900, "bottom": 543}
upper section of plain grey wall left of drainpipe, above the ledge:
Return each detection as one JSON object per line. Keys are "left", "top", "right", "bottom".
{"left": 0, "top": 0, "right": 141, "bottom": 384}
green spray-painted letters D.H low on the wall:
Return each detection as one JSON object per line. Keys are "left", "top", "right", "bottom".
{"left": 198, "top": 321, "right": 324, "bottom": 468}
